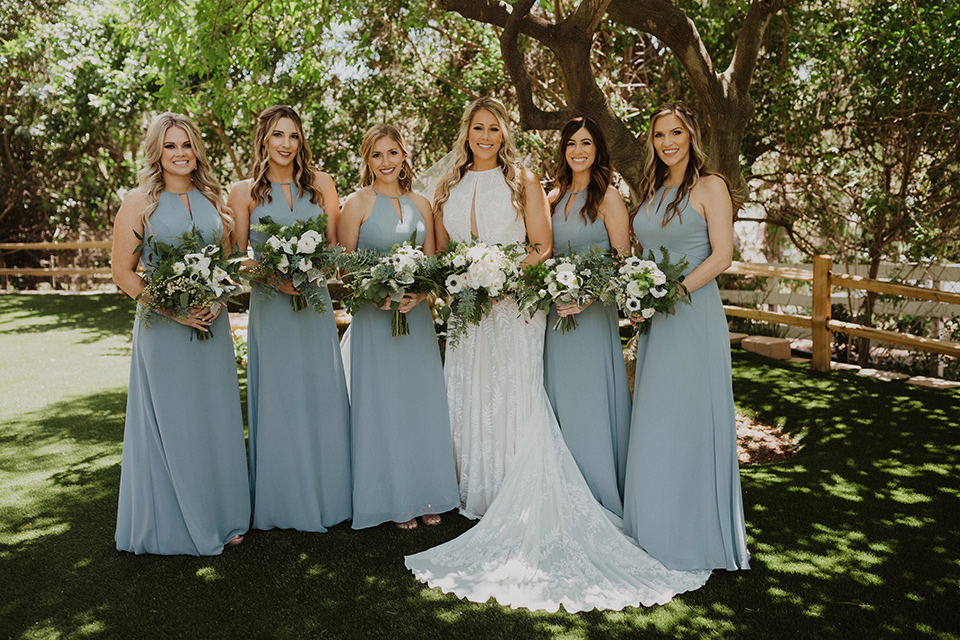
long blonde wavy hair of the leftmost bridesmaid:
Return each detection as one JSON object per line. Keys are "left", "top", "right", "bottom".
{"left": 137, "top": 111, "right": 233, "bottom": 231}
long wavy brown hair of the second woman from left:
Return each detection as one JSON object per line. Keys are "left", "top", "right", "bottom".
{"left": 250, "top": 104, "right": 323, "bottom": 207}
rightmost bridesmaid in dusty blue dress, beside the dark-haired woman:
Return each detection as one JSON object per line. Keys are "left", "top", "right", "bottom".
{"left": 623, "top": 104, "right": 750, "bottom": 571}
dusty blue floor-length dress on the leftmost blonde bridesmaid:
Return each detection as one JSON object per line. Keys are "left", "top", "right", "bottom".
{"left": 116, "top": 190, "right": 250, "bottom": 556}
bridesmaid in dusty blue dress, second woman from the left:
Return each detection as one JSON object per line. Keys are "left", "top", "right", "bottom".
{"left": 229, "top": 106, "right": 351, "bottom": 532}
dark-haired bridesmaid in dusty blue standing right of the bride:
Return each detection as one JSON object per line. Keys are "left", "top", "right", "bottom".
{"left": 543, "top": 118, "right": 630, "bottom": 517}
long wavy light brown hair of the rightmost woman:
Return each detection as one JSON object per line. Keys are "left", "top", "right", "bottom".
{"left": 630, "top": 102, "right": 743, "bottom": 228}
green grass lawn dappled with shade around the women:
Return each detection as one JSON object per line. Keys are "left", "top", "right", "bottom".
{"left": 0, "top": 295, "right": 960, "bottom": 640}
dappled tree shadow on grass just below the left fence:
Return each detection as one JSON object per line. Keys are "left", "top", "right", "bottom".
{"left": 0, "top": 293, "right": 136, "bottom": 342}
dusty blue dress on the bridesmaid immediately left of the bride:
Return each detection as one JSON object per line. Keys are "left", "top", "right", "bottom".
{"left": 350, "top": 195, "right": 460, "bottom": 529}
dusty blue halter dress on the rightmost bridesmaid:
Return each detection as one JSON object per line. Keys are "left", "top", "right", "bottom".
{"left": 624, "top": 187, "right": 750, "bottom": 571}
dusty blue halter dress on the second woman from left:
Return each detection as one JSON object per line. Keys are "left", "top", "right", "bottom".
{"left": 247, "top": 183, "right": 351, "bottom": 532}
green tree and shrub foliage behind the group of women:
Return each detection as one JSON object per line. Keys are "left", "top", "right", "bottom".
{"left": 0, "top": 0, "right": 960, "bottom": 276}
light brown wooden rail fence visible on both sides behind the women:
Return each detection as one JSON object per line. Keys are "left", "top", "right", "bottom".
{"left": 0, "top": 240, "right": 960, "bottom": 371}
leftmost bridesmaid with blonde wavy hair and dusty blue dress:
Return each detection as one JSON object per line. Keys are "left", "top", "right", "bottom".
{"left": 112, "top": 113, "right": 250, "bottom": 556}
